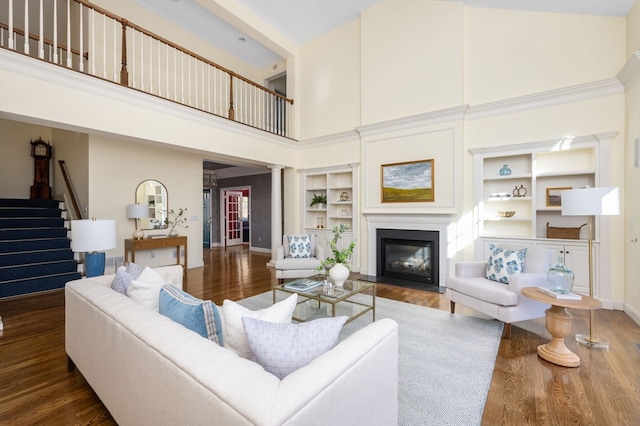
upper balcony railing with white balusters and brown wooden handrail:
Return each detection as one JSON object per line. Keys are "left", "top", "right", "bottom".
{"left": 0, "top": 0, "right": 293, "bottom": 137}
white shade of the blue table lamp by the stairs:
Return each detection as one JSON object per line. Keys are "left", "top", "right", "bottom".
{"left": 71, "top": 219, "right": 117, "bottom": 252}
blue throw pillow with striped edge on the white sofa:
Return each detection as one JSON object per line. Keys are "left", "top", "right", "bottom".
{"left": 159, "top": 284, "right": 223, "bottom": 346}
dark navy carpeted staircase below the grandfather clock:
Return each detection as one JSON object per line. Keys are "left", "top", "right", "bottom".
{"left": 0, "top": 199, "right": 81, "bottom": 298}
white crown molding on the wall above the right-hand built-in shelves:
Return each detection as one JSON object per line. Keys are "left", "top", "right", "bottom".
{"left": 465, "top": 78, "right": 624, "bottom": 120}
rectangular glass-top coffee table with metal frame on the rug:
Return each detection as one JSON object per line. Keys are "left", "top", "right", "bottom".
{"left": 273, "top": 275, "right": 376, "bottom": 324}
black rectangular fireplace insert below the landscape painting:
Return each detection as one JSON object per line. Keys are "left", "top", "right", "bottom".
{"left": 376, "top": 229, "right": 440, "bottom": 291}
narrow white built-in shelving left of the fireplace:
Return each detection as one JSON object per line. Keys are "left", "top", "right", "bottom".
{"left": 300, "top": 164, "right": 358, "bottom": 272}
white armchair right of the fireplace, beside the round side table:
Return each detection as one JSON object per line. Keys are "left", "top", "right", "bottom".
{"left": 445, "top": 246, "right": 552, "bottom": 339}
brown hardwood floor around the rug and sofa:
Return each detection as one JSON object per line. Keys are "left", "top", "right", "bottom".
{"left": 0, "top": 247, "right": 640, "bottom": 425}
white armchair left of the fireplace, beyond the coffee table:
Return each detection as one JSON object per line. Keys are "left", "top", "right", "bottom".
{"left": 274, "top": 234, "right": 325, "bottom": 282}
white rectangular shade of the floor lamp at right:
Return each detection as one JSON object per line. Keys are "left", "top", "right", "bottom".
{"left": 562, "top": 187, "right": 620, "bottom": 216}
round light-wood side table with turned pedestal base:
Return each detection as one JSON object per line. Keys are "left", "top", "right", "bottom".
{"left": 522, "top": 287, "right": 602, "bottom": 367}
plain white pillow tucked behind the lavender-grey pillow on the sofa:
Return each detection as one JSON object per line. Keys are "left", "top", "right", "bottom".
{"left": 222, "top": 294, "right": 298, "bottom": 359}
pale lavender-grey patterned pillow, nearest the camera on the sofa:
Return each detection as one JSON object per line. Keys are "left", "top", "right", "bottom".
{"left": 242, "top": 317, "right": 347, "bottom": 379}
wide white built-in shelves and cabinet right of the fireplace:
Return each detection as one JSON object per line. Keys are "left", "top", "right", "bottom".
{"left": 470, "top": 133, "right": 615, "bottom": 297}
